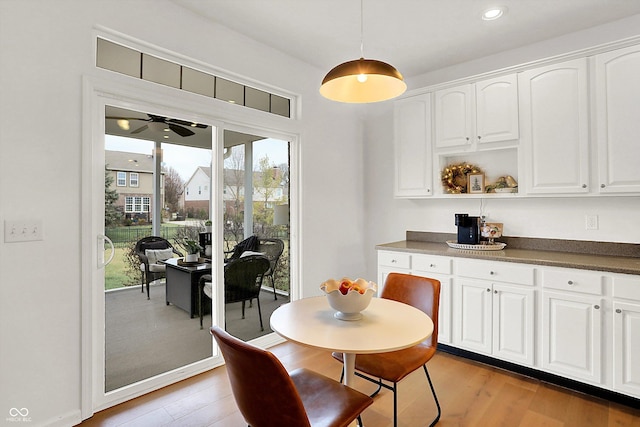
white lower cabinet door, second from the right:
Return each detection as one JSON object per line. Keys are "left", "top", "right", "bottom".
{"left": 542, "top": 292, "right": 602, "bottom": 384}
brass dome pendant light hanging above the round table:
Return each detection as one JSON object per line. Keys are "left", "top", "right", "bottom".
{"left": 320, "top": 0, "right": 407, "bottom": 103}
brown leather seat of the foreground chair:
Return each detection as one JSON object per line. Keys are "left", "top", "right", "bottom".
{"left": 292, "top": 368, "right": 371, "bottom": 427}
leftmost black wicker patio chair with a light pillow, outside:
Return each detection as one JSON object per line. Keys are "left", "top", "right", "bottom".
{"left": 134, "top": 236, "right": 183, "bottom": 299}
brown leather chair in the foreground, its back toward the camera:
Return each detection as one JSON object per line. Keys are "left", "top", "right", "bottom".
{"left": 211, "top": 326, "right": 373, "bottom": 427}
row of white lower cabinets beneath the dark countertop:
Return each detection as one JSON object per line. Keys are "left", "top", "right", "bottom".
{"left": 378, "top": 251, "right": 640, "bottom": 399}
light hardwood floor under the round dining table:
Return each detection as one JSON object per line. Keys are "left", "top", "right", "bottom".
{"left": 80, "top": 342, "right": 640, "bottom": 427}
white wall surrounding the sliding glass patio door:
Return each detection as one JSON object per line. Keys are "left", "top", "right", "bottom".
{"left": 0, "top": 0, "right": 365, "bottom": 426}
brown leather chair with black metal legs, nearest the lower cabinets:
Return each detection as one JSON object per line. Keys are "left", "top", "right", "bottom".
{"left": 332, "top": 273, "right": 441, "bottom": 426}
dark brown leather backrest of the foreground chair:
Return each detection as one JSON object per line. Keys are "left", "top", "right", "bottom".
{"left": 211, "top": 326, "right": 312, "bottom": 427}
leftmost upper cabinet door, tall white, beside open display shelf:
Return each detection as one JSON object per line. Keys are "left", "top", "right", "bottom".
{"left": 394, "top": 94, "right": 433, "bottom": 197}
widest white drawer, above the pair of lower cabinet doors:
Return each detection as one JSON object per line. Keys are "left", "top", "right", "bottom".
{"left": 456, "top": 260, "right": 534, "bottom": 286}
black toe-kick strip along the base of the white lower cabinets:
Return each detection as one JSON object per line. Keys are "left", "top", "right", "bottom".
{"left": 438, "top": 344, "right": 640, "bottom": 409}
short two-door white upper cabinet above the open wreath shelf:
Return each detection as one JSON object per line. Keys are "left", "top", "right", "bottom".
{"left": 435, "top": 74, "right": 518, "bottom": 148}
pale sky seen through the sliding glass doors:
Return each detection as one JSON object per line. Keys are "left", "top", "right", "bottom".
{"left": 105, "top": 135, "right": 288, "bottom": 182}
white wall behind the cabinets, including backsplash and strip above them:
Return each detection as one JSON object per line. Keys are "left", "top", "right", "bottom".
{"left": 364, "top": 15, "right": 640, "bottom": 277}
